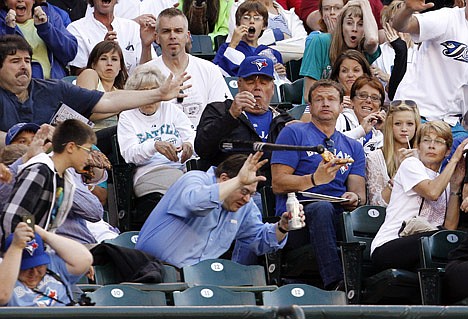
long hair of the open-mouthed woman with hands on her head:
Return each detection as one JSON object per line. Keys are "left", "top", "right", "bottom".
{"left": 329, "top": 5, "right": 364, "bottom": 65}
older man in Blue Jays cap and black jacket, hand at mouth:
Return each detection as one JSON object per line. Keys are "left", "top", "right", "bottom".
{"left": 195, "top": 55, "right": 293, "bottom": 264}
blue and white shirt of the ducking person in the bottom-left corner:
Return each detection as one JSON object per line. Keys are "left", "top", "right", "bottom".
{"left": 7, "top": 252, "right": 81, "bottom": 307}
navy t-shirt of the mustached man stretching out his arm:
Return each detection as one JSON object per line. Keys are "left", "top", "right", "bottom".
{"left": 0, "top": 79, "right": 104, "bottom": 132}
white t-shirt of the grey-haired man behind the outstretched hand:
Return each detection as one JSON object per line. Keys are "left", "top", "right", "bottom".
{"left": 148, "top": 54, "right": 232, "bottom": 128}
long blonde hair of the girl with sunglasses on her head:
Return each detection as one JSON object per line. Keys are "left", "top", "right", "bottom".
{"left": 382, "top": 102, "right": 421, "bottom": 178}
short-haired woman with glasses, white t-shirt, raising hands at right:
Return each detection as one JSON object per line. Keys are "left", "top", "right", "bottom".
{"left": 371, "top": 121, "right": 468, "bottom": 271}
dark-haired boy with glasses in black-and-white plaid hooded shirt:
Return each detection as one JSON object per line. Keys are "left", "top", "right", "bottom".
{"left": 0, "top": 120, "right": 96, "bottom": 245}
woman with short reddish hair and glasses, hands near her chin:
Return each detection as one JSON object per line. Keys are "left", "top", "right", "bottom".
{"left": 336, "top": 75, "right": 385, "bottom": 155}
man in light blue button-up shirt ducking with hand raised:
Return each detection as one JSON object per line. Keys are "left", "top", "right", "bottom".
{"left": 135, "top": 152, "right": 304, "bottom": 268}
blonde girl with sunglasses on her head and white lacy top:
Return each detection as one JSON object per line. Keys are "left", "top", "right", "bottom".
{"left": 366, "top": 100, "right": 421, "bottom": 207}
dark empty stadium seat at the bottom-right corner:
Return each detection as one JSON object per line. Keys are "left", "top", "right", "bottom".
{"left": 418, "top": 230, "right": 467, "bottom": 305}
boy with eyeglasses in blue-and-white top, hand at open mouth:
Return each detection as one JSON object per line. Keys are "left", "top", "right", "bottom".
{"left": 213, "top": 1, "right": 286, "bottom": 76}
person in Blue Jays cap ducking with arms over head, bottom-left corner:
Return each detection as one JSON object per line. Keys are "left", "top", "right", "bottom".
{"left": 0, "top": 222, "right": 93, "bottom": 307}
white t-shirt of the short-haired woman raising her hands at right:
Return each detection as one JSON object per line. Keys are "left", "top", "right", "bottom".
{"left": 371, "top": 157, "right": 448, "bottom": 254}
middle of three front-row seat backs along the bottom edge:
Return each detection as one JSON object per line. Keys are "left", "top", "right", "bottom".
{"left": 173, "top": 285, "right": 256, "bottom": 306}
